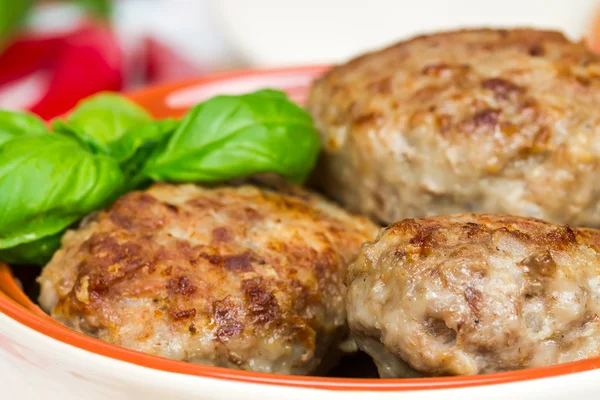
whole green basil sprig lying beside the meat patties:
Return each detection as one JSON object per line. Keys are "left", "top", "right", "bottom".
{"left": 0, "top": 90, "right": 319, "bottom": 265}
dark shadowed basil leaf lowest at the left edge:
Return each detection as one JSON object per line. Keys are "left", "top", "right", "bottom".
{"left": 0, "top": 232, "right": 62, "bottom": 266}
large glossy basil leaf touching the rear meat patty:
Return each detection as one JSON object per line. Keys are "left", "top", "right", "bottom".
{"left": 141, "top": 90, "right": 320, "bottom": 182}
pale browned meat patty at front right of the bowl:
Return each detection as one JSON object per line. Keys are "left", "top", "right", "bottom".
{"left": 346, "top": 215, "right": 600, "bottom": 377}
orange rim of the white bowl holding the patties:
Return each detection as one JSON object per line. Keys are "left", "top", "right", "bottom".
{"left": 0, "top": 66, "right": 600, "bottom": 391}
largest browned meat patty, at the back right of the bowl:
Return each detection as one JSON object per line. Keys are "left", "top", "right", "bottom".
{"left": 308, "top": 29, "right": 600, "bottom": 226}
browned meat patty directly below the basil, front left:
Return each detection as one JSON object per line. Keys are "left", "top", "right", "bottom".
{"left": 38, "top": 184, "right": 376, "bottom": 374}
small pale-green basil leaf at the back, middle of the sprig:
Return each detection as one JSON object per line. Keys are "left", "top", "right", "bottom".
{"left": 52, "top": 92, "right": 152, "bottom": 154}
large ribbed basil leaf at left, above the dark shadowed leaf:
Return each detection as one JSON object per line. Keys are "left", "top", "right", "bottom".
{"left": 0, "top": 135, "right": 124, "bottom": 253}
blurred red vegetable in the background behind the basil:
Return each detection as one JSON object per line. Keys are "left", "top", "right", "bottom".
{"left": 0, "top": 22, "right": 124, "bottom": 119}
